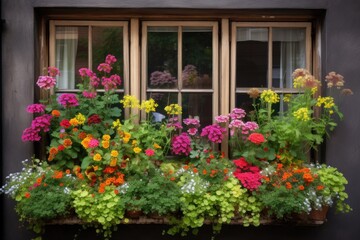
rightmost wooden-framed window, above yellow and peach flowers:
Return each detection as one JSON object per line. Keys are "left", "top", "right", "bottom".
{"left": 231, "top": 22, "right": 311, "bottom": 113}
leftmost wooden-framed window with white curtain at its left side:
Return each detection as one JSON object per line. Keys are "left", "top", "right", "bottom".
{"left": 49, "top": 21, "right": 129, "bottom": 93}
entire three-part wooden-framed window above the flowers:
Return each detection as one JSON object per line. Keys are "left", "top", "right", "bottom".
{"left": 49, "top": 16, "right": 312, "bottom": 152}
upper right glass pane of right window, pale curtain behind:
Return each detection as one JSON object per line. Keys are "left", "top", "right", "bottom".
{"left": 272, "top": 28, "right": 306, "bottom": 88}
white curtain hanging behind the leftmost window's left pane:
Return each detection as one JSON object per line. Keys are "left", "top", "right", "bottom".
{"left": 55, "top": 27, "right": 79, "bottom": 89}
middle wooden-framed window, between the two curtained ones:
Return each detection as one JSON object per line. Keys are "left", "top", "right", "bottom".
{"left": 142, "top": 22, "right": 218, "bottom": 126}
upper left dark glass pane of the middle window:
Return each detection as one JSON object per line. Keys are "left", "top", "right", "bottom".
{"left": 147, "top": 27, "right": 178, "bottom": 89}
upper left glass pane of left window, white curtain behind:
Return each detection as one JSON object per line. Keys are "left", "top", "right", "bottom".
{"left": 55, "top": 26, "right": 88, "bottom": 89}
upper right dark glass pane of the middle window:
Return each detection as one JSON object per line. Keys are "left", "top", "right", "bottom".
{"left": 182, "top": 27, "right": 212, "bottom": 89}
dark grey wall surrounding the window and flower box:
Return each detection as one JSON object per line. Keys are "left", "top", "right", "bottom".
{"left": 1, "top": 0, "right": 360, "bottom": 240}
